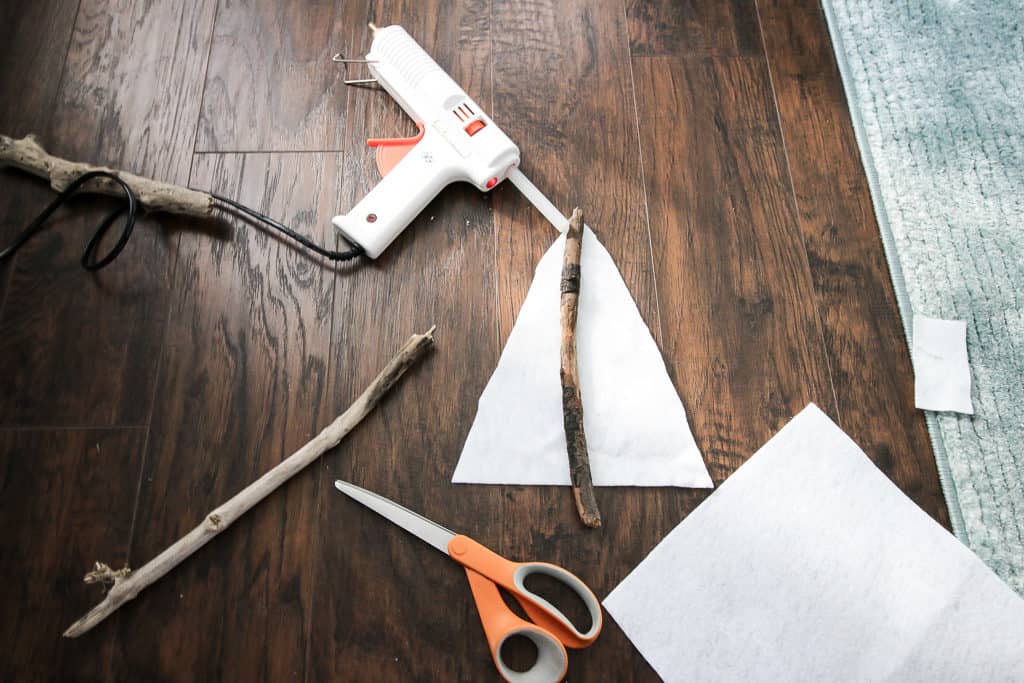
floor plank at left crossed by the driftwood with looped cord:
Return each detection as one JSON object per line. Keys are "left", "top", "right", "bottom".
{"left": 0, "top": 0, "right": 213, "bottom": 425}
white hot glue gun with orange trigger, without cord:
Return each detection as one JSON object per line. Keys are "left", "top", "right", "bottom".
{"left": 333, "top": 26, "right": 519, "bottom": 258}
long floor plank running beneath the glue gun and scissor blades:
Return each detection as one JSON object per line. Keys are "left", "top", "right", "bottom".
{"left": 309, "top": 0, "right": 506, "bottom": 681}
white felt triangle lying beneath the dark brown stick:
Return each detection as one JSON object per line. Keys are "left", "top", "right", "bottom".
{"left": 452, "top": 228, "right": 713, "bottom": 488}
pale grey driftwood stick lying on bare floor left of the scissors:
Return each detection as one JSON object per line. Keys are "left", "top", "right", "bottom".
{"left": 63, "top": 328, "right": 434, "bottom": 638}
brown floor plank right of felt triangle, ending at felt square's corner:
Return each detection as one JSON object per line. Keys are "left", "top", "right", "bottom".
{"left": 634, "top": 57, "right": 836, "bottom": 481}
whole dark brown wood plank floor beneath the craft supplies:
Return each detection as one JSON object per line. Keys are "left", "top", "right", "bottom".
{"left": 0, "top": 0, "right": 948, "bottom": 681}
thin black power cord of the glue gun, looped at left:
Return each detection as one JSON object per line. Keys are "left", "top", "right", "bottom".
{"left": 0, "top": 171, "right": 365, "bottom": 270}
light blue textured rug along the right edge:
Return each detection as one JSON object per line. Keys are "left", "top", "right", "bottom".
{"left": 823, "top": 0, "right": 1024, "bottom": 594}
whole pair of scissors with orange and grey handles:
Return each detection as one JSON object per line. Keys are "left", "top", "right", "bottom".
{"left": 334, "top": 480, "right": 602, "bottom": 683}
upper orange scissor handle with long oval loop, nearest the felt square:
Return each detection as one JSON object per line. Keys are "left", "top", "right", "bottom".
{"left": 449, "top": 535, "right": 603, "bottom": 648}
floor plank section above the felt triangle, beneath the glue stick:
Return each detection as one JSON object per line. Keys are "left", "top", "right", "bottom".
{"left": 492, "top": 0, "right": 660, "bottom": 343}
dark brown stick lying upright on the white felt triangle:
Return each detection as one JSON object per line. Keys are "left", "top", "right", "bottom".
{"left": 559, "top": 207, "right": 601, "bottom": 528}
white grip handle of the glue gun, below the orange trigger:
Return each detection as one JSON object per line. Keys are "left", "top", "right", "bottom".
{"left": 333, "top": 137, "right": 458, "bottom": 258}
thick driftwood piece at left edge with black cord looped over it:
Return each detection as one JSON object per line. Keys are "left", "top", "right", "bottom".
{"left": 0, "top": 135, "right": 213, "bottom": 218}
